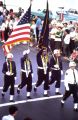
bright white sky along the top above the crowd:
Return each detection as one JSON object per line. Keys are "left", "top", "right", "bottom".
{"left": 2, "top": 0, "right": 78, "bottom": 11}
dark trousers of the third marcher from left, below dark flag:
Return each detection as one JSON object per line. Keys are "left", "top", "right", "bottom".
{"left": 36, "top": 69, "right": 49, "bottom": 90}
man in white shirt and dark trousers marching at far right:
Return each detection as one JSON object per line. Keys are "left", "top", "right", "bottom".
{"left": 61, "top": 61, "right": 78, "bottom": 112}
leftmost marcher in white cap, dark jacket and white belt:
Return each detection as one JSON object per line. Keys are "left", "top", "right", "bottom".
{"left": 2, "top": 53, "right": 16, "bottom": 102}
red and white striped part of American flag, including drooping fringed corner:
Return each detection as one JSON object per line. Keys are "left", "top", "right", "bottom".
{"left": 2, "top": 23, "right": 30, "bottom": 56}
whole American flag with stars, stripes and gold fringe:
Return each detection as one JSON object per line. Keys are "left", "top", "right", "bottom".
{"left": 2, "top": 5, "right": 31, "bottom": 55}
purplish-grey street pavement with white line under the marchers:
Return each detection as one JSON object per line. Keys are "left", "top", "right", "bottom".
{"left": 0, "top": 44, "right": 78, "bottom": 120}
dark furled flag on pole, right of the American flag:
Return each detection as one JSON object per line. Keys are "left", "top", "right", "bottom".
{"left": 39, "top": 1, "right": 49, "bottom": 48}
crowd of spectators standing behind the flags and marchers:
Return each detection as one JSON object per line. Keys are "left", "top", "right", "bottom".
{"left": 0, "top": 2, "right": 78, "bottom": 61}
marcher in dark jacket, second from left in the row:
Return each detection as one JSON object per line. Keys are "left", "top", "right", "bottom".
{"left": 17, "top": 49, "right": 33, "bottom": 99}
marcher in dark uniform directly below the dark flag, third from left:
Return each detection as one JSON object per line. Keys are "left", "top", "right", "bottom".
{"left": 34, "top": 48, "right": 49, "bottom": 96}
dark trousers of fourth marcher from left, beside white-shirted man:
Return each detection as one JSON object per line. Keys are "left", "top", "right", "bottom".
{"left": 49, "top": 70, "right": 61, "bottom": 88}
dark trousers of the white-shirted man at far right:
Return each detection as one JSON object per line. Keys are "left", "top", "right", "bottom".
{"left": 63, "top": 84, "right": 78, "bottom": 103}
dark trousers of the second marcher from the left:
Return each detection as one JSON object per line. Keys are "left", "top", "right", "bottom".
{"left": 18, "top": 74, "right": 32, "bottom": 92}
